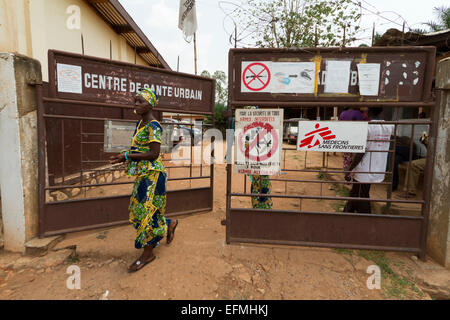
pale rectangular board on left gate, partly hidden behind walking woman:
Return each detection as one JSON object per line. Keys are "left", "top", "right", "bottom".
{"left": 103, "top": 120, "right": 174, "bottom": 153}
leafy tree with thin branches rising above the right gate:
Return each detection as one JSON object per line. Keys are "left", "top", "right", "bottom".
{"left": 232, "top": 0, "right": 361, "bottom": 48}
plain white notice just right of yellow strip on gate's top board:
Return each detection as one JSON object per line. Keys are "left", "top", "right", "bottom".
{"left": 324, "top": 60, "right": 351, "bottom": 93}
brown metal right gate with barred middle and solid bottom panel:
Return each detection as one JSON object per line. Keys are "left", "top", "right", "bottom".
{"left": 226, "top": 47, "right": 439, "bottom": 259}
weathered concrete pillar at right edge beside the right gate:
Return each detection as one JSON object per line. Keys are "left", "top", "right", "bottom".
{"left": 427, "top": 58, "right": 450, "bottom": 268}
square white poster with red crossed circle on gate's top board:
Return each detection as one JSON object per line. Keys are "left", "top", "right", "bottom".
{"left": 241, "top": 61, "right": 272, "bottom": 92}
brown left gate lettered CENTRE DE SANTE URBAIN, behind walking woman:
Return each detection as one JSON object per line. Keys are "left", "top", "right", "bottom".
{"left": 37, "top": 51, "right": 215, "bottom": 236}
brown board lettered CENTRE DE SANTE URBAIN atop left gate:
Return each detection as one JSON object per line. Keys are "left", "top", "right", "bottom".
{"left": 49, "top": 51, "right": 215, "bottom": 114}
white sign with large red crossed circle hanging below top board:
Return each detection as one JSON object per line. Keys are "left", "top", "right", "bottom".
{"left": 234, "top": 109, "right": 283, "bottom": 175}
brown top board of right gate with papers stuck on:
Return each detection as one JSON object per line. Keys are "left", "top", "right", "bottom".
{"left": 229, "top": 47, "right": 436, "bottom": 107}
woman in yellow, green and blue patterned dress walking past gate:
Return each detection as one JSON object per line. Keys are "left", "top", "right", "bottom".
{"left": 110, "top": 88, "right": 178, "bottom": 272}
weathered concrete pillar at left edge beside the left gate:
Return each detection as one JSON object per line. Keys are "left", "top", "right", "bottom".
{"left": 0, "top": 53, "right": 42, "bottom": 252}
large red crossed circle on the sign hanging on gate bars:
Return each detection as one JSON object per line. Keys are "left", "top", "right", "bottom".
{"left": 239, "top": 122, "right": 278, "bottom": 162}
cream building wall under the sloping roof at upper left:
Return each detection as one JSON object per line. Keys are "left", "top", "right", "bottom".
{"left": 0, "top": 0, "right": 148, "bottom": 81}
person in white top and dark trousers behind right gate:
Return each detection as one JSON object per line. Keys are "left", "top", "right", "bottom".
{"left": 344, "top": 108, "right": 394, "bottom": 213}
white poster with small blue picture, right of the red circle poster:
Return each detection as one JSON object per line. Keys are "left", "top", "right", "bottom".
{"left": 270, "top": 62, "right": 316, "bottom": 93}
